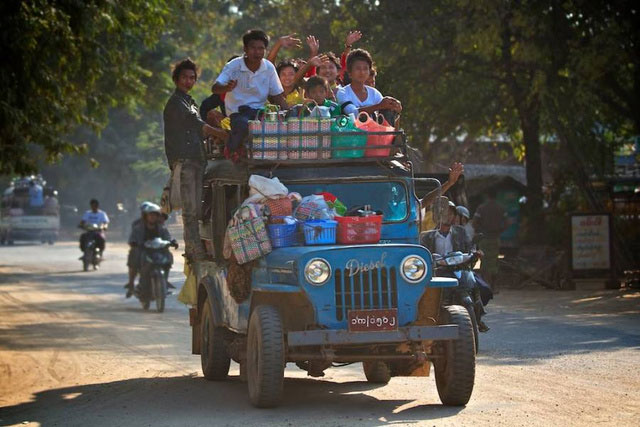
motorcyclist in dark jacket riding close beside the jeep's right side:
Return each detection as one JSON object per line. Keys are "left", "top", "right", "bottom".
{"left": 420, "top": 201, "right": 489, "bottom": 332}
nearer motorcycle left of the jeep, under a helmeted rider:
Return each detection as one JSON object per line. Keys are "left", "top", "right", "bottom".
{"left": 136, "top": 237, "right": 178, "bottom": 313}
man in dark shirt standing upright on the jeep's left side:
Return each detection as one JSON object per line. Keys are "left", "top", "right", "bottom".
{"left": 164, "top": 58, "right": 228, "bottom": 261}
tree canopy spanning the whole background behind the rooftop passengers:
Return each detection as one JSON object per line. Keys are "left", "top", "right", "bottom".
{"left": 0, "top": 0, "right": 640, "bottom": 227}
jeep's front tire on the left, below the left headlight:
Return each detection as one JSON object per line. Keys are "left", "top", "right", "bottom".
{"left": 247, "top": 305, "right": 285, "bottom": 408}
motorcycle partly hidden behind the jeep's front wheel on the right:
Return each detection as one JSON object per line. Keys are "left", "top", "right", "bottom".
{"left": 433, "top": 251, "right": 480, "bottom": 353}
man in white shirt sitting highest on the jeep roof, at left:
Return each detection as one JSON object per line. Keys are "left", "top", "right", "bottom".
{"left": 211, "top": 30, "right": 288, "bottom": 153}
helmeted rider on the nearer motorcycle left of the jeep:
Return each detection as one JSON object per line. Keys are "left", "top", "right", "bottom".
{"left": 125, "top": 202, "right": 177, "bottom": 298}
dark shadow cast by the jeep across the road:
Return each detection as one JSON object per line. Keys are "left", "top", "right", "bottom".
{"left": 0, "top": 376, "right": 463, "bottom": 426}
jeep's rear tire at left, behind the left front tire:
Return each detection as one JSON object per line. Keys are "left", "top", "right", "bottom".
{"left": 200, "top": 298, "right": 231, "bottom": 381}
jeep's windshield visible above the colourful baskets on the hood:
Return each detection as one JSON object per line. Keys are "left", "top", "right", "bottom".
{"left": 286, "top": 181, "right": 408, "bottom": 222}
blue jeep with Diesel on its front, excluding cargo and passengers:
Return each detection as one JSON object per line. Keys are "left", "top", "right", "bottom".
{"left": 190, "top": 135, "right": 475, "bottom": 407}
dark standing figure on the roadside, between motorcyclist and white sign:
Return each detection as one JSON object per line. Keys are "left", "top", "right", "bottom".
{"left": 473, "top": 188, "right": 508, "bottom": 293}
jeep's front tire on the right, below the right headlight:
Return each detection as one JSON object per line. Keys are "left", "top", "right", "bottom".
{"left": 434, "top": 305, "right": 476, "bottom": 406}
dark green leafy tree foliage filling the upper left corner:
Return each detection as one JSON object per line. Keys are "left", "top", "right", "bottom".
{"left": 0, "top": 0, "right": 171, "bottom": 174}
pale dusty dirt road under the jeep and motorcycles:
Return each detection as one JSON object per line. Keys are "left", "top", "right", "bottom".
{"left": 0, "top": 242, "right": 640, "bottom": 427}
